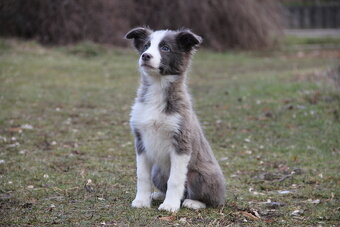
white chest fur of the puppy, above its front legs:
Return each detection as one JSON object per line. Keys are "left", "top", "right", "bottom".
{"left": 130, "top": 78, "right": 181, "bottom": 168}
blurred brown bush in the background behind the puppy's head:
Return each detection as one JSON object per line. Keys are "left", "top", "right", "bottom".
{"left": 0, "top": 0, "right": 282, "bottom": 50}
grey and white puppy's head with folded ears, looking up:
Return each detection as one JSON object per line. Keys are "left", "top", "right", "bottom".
{"left": 125, "top": 27, "right": 202, "bottom": 75}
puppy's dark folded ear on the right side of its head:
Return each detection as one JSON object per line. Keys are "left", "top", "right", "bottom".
{"left": 176, "top": 30, "right": 203, "bottom": 52}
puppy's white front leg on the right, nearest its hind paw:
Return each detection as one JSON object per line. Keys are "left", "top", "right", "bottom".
{"left": 158, "top": 152, "right": 190, "bottom": 212}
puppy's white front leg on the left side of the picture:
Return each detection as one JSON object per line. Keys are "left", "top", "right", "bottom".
{"left": 132, "top": 152, "right": 152, "bottom": 208}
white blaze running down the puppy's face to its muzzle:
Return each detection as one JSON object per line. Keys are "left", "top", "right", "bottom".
{"left": 138, "top": 30, "right": 167, "bottom": 70}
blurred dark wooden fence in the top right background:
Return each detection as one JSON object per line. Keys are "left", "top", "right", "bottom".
{"left": 286, "top": 3, "right": 340, "bottom": 28}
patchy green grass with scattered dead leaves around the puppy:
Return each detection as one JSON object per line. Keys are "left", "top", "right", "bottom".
{"left": 0, "top": 39, "right": 340, "bottom": 226}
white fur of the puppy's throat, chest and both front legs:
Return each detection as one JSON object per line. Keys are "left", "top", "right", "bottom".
{"left": 130, "top": 72, "right": 190, "bottom": 212}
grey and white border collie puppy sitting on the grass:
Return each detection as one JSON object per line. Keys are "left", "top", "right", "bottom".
{"left": 125, "top": 27, "right": 225, "bottom": 212}
